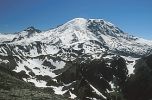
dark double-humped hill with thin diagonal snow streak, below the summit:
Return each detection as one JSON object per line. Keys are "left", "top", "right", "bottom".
{"left": 79, "top": 57, "right": 128, "bottom": 100}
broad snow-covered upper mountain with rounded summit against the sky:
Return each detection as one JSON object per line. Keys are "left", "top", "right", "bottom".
{"left": 2, "top": 18, "right": 152, "bottom": 56}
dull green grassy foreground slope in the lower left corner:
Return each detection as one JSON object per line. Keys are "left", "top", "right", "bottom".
{"left": 0, "top": 66, "right": 70, "bottom": 100}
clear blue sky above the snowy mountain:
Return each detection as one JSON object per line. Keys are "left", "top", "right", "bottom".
{"left": 0, "top": 0, "right": 152, "bottom": 40}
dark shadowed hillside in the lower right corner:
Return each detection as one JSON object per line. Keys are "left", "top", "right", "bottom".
{"left": 124, "top": 55, "right": 152, "bottom": 100}
